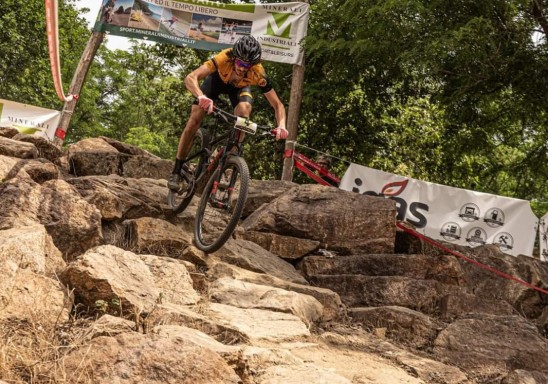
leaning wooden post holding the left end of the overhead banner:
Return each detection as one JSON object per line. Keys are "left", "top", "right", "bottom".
{"left": 53, "top": 32, "right": 105, "bottom": 147}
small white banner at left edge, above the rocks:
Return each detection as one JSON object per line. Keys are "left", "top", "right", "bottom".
{"left": 0, "top": 99, "right": 61, "bottom": 140}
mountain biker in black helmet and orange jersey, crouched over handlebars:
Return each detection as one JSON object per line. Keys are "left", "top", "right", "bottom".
{"left": 168, "top": 35, "right": 288, "bottom": 191}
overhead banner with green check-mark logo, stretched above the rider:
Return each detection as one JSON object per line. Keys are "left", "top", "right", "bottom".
{"left": 94, "top": 0, "right": 309, "bottom": 64}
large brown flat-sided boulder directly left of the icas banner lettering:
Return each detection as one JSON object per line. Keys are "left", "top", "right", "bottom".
{"left": 243, "top": 185, "right": 396, "bottom": 254}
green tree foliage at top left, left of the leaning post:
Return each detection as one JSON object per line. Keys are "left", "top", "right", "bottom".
{"left": 0, "top": 0, "right": 89, "bottom": 109}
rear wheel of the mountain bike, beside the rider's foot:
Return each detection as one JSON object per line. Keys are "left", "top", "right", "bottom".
{"left": 167, "top": 129, "right": 208, "bottom": 214}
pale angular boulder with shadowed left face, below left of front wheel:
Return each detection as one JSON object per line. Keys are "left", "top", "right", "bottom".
{"left": 61, "top": 245, "right": 198, "bottom": 320}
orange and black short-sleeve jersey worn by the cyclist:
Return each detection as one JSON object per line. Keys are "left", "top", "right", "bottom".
{"left": 204, "top": 48, "right": 272, "bottom": 93}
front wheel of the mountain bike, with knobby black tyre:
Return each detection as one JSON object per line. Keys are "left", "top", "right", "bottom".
{"left": 194, "top": 156, "right": 249, "bottom": 253}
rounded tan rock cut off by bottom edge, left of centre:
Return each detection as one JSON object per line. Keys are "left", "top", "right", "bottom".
{"left": 64, "top": 333, "right": 240, "bottom": 384}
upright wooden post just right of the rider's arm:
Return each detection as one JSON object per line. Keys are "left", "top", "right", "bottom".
{"left": 282, "top": 57, "right": 304, "bottom": 181}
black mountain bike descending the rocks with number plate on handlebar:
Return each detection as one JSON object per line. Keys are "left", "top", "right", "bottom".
{"left": 168, "top": 107, "right": 273, "bottom": 253}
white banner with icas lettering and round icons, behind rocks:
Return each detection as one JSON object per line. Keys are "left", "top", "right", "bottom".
{"left": 340, "top": 164, "right": 538, "bottom": 256}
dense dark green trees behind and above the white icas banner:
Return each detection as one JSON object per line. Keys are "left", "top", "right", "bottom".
{"left": 302, "top": 0, "right": 548, "bottom": 200}
